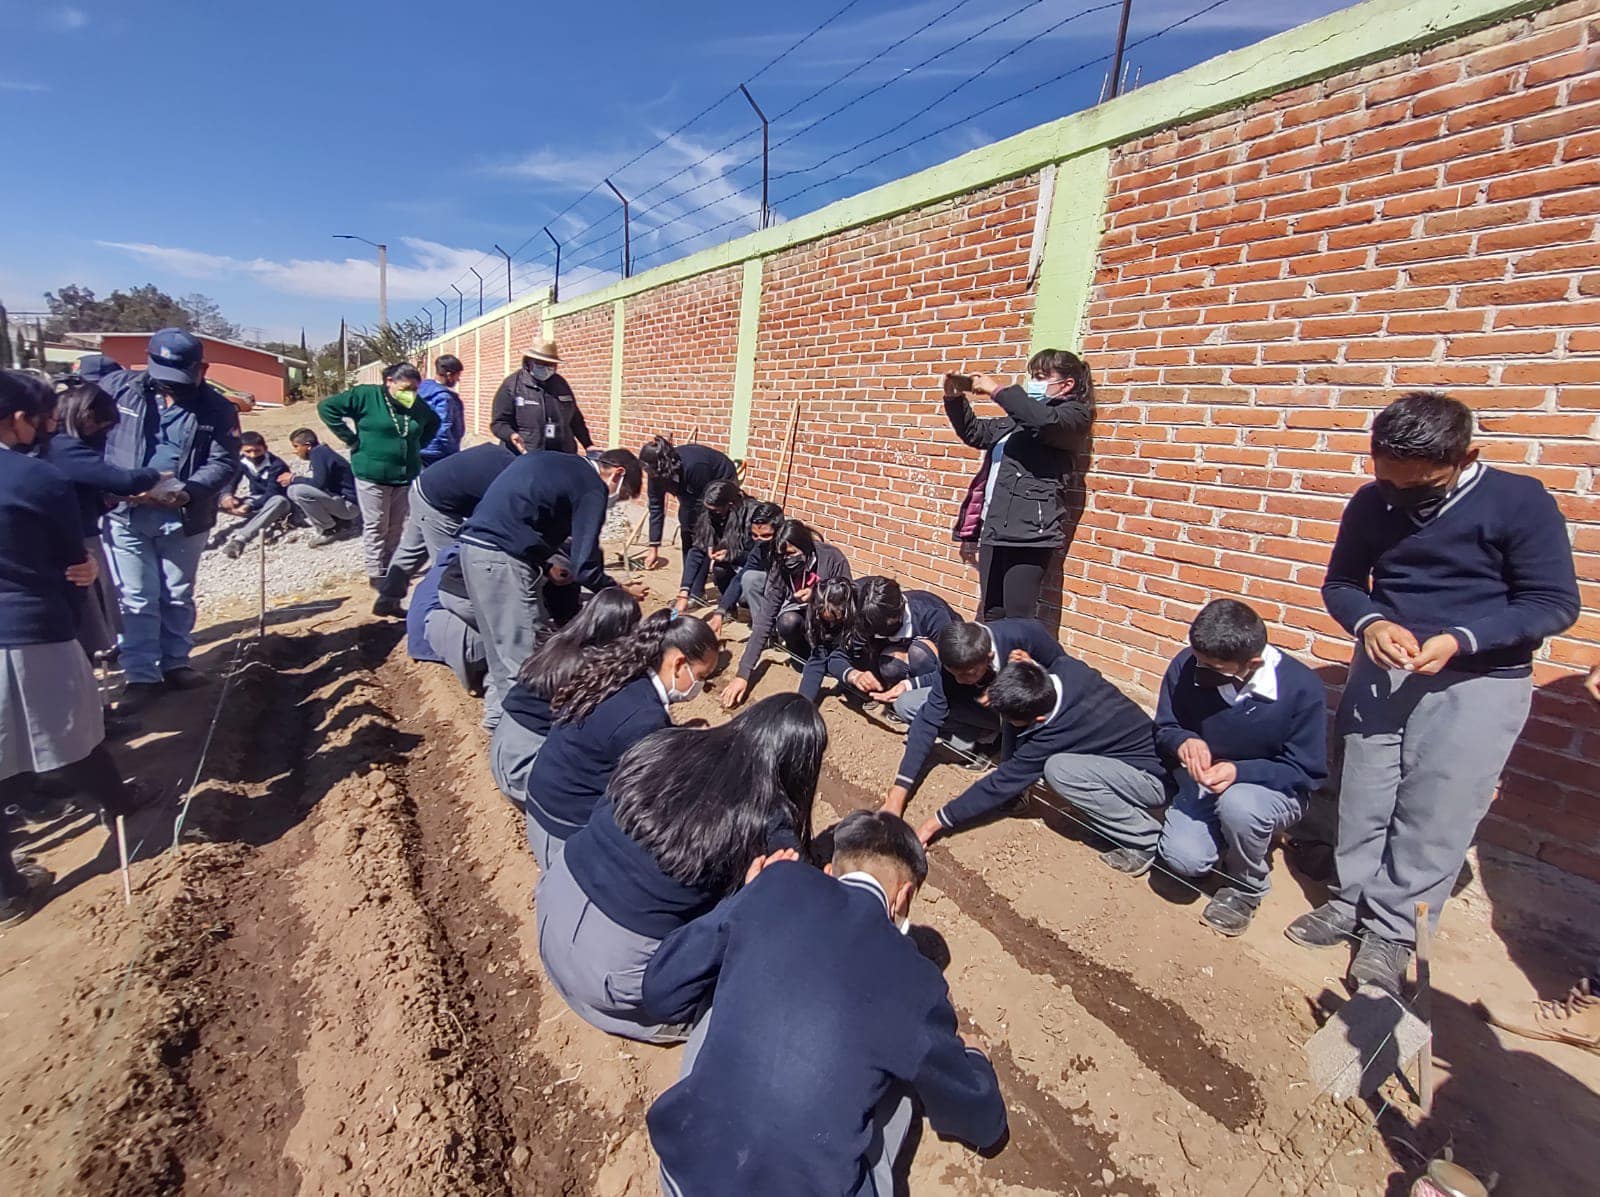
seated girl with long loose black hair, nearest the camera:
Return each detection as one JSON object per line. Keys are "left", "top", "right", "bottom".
{"left": 534, "top": 695, "right": 827, "bottom": 1043}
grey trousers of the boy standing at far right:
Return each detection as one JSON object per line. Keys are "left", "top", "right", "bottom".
{"left": 1330, "top": 650, "right": 1533, "bottom": 946}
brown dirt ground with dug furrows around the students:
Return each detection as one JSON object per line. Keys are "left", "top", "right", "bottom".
{"left": 0, "top": 410, "right": 1600, "bottom": 1197}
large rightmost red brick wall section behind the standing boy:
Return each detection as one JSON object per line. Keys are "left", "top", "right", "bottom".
{"left": 1064, "top": 0, "right": 1600, "bottom": 879}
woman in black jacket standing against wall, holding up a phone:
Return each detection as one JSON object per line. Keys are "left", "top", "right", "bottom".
{"left": 944, "top": 349, "right": 1094, "bottom": 619}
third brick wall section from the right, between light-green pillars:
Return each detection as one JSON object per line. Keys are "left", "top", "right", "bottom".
{"left": 622, "top": 266, "right": 744, "bottom": 451}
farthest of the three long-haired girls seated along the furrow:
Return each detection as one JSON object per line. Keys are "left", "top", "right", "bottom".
{"left": 490, "top": 585, "right": 640, "bottom": 810}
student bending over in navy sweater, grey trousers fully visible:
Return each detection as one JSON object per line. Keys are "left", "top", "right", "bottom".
{"left": 454, "top": 450, "right": 645, "bottom": 731}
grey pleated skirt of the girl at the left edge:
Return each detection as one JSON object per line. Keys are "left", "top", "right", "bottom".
{"left": 0, "top": 640, "right": 106, "bottom": 781}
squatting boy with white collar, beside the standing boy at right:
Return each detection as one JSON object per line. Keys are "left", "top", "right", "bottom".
{"left": 1152, "top": 599, "right": 1328, "bottom": 936}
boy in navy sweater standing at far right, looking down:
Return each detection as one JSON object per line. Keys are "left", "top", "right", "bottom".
{"left": 1288, "top": 392, "right": 1579, "bottom": 992}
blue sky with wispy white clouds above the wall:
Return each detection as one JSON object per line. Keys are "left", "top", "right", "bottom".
{"left": 0, "top": 0, "right": 1347, "bottom": 341}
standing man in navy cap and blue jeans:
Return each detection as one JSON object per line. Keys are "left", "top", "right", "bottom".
{"left": 101, "top": 328, "right": 238, "bottom": 712}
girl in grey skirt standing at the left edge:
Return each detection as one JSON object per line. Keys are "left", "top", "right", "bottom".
{"left": 0, "top": 370, "right": 155, "bottom": 927}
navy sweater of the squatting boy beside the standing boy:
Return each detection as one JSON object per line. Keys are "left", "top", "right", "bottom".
{"left": 1155, "top": 648, "right": 1328, "bottom": 797}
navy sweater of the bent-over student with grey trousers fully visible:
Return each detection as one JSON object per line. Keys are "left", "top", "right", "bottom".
{"left": 464, "top": 453, "right": 614, "bottom": 590}
